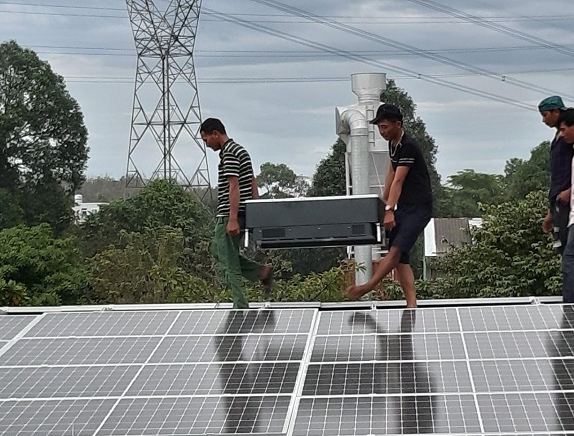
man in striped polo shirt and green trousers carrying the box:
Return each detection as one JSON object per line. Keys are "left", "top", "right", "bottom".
{"left": 200, "top": 118, "right": 273, "bottom": 309}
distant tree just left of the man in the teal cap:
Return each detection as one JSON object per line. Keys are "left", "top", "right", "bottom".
{"left": 504, "top": 141, "right": 550, "bottom": 200}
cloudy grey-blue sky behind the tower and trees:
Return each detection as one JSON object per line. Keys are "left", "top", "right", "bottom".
{"left": 0, "top": 0, "right": 574, "bottom": 183}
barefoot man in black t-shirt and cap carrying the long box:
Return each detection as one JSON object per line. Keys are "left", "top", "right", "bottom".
{"left": 345, "top": 104, "right": 432, "bottom": 307}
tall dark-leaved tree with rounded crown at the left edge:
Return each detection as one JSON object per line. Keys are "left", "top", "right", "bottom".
{"left": 0, "top": 41, "right": 88, "bottom": 229}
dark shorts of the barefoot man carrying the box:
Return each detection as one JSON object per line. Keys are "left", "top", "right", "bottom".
{"left": 387, "top": 205, "right": 432, "bottom": 264}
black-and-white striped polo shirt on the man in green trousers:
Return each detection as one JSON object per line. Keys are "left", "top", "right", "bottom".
{"left": 217, "top": 139, "right": 253, "bottom": 216}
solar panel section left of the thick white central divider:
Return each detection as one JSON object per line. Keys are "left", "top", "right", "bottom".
{"left": 0, "top": 309, "right": 317, "bottom": 435}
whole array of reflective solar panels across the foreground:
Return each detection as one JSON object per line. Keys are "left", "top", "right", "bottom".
{"left": 0, "top": 304, "right": 574, "bottom": 436}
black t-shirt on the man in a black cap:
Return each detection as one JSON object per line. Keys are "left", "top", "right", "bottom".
{"left": 389, "top": 133, "right": 432, "bottom": 207}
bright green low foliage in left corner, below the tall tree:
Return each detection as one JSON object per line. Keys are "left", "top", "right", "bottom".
{"left": 0, "top": 224, "right": 87, "bottom": 306}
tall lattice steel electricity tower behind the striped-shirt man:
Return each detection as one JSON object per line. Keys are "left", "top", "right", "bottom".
{"left": 126, "top": 0, "right": 210, "bottom": 192}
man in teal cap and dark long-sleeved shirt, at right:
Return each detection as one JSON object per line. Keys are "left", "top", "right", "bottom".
{"left": 538, "top": 95, "right": 573, "bottom": 255}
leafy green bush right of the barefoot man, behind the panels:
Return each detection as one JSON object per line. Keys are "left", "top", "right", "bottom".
{"left": 425, "top": 191, "right": 561, "bottom": 298}
